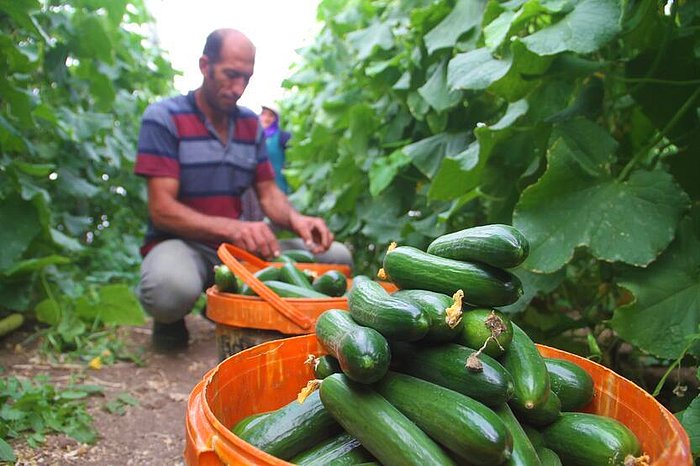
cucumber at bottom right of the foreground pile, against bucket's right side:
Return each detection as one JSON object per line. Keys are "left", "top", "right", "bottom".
{"left": 542, "top": 413, "right": 640, "bottom": 466}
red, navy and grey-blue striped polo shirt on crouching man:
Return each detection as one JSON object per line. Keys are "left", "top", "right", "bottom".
{"left": 134, "top": 91, "right": 275, "bottom": 254}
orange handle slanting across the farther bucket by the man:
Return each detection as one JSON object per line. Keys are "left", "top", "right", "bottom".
{"left": 217, "top": 243, "right": 312, "bottom": 330}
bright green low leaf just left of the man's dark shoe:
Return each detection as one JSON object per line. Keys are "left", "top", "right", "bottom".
{"left": 75, "top": 284, "right": 145, "bottom": 325}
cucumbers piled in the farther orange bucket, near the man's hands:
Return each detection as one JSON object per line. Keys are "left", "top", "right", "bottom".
{"left": 214, "top": 249, "right": 347, "bottom": 299}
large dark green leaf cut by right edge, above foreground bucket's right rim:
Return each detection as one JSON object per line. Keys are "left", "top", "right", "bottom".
{"left": 612, "top": 218, "right": 700, "bottom": 358}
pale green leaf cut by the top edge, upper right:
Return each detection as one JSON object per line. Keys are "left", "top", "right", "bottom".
{"left": 522, "top": 0, "right": 622, "bottom": 55}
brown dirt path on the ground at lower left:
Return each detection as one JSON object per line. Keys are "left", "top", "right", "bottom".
{"left": 0, "top": 315, "right": 218, "bottom": 466}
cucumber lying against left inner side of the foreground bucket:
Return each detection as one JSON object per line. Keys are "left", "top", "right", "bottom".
{"left": 239, "top": 392, "right": 340, "bottom": 460}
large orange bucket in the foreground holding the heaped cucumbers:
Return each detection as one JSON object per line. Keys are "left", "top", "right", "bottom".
{"left": 184, "top": 335, "right": 693, "bottom": 466}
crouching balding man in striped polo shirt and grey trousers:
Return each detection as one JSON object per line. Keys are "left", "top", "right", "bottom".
{"left": 134, "top": 29, "right": 346, "bottom": 351}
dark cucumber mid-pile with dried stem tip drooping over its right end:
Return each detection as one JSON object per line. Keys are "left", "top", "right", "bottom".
{"left": 391, "top": 343, "right": 513, "bottom": 407}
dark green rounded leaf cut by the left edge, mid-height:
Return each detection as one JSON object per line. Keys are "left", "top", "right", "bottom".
{"left": 0, "top": 195, "right": 41, "bottom": 272}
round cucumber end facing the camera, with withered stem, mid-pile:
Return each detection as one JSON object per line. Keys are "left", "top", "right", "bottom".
{"left": 455, "top": 309, "right": 513, "bottom": 358}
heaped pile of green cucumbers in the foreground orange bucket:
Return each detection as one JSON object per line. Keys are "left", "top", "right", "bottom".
{"left": 233, "top": 225, "right": 648, "bottom": 466}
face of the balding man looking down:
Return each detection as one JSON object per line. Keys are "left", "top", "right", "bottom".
{"left": 200, "top": 37, "right": 255, "bottom": 113}
